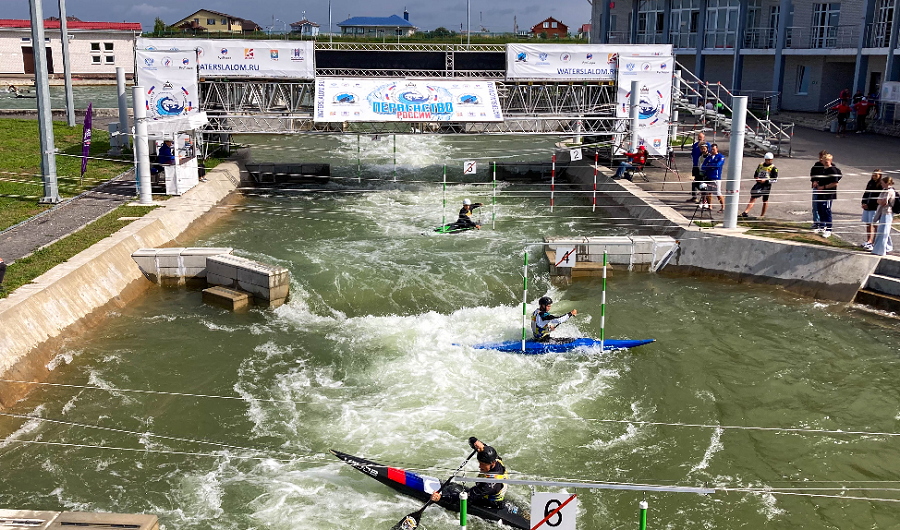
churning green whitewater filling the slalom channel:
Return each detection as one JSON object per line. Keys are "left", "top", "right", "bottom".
{"left": 0, "top": 137, "right": 900, "bottom": 530}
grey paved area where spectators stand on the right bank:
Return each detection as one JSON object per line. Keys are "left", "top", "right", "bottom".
{"left": 636, "top": 122, "right": 900, "bottom": 251}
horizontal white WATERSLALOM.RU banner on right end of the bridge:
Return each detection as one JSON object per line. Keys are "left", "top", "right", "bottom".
{"left": 506, "top": 44, "right": 672, "bottom": 81}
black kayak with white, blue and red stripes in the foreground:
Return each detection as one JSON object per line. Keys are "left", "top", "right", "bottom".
{"left": 331, "top": 449, "right": 531, "bottom": 530}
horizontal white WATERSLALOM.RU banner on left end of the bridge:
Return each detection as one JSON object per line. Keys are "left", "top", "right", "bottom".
{"left": 136, "top": 38, "right": 316, "bottom": 79}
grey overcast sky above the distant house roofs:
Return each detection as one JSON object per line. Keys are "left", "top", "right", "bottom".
{"left": 8, "top": 0, "right": 591, "bottom": 33}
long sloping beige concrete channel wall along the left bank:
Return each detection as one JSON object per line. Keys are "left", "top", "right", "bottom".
{"left": 0, "top": 162, "right": 240, "bottom": 408}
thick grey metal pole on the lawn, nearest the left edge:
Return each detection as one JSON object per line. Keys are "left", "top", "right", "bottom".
{"left": 29, "top": 0, "right": 60, "bottom": 204}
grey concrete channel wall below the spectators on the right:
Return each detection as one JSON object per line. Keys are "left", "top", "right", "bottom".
{"left": 569, "top": 161, "right": 880, "bottom": 303}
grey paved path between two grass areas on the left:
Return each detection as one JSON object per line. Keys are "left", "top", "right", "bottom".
{"left": 0, "top": 170, "right": 136, "bottom": 263}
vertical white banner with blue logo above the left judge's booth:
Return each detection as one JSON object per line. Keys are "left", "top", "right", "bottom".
{"left": 134, "top": 50, "right": 199, "bottom": 118}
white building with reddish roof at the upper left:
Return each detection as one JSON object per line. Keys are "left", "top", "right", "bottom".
{"left": 0, "top": 17, "right": 141, "bottom": 78}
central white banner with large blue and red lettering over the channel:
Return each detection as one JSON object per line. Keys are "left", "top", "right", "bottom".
{"left": 315, "top": 77, "right": 503, "bottom": 122}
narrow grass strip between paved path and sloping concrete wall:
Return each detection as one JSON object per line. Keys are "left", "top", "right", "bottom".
{"left": 0, "top": 206, "right": 156, "bottom": 298}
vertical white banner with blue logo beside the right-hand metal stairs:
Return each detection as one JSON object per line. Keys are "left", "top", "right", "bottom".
{"left": 616, "top": 56, "right": 675, "bottom": 155}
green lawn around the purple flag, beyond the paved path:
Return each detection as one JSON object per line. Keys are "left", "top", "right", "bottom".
{"left": 0, "top": 119, "right": 133, "bottom": 230}
